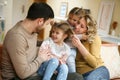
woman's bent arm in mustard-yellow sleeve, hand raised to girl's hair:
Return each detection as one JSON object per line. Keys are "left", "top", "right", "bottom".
{"left": 72, "top": 36, "right": 101, "bottom": 67}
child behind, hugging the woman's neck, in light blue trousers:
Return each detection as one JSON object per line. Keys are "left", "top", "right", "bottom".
{"left": 65, "top": 7, "right": 87, "bottom": 73}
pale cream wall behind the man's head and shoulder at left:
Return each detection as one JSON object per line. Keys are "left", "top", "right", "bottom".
{"left": 3, "top": 0, "right": 33, "bottom": 34}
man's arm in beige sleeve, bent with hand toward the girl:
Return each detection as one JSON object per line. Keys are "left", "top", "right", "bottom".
{"left": 6, "top": 34, "right": 47, "bottom": 79}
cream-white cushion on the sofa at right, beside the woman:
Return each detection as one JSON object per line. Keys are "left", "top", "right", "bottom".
{"left": 101, "top": 44, "right": 120, "bottom": 79}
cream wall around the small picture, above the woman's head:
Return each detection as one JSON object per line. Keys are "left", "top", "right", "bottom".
{"left": 47, "top": 0, "right": 101, "bottom": 19}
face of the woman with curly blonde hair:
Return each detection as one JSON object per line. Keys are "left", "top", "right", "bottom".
{"left": 74, "top": 18, "right": 87, "bottom": 34}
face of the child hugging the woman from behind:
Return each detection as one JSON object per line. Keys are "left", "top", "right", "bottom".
{"left": 68, "top": 14, "right": 79, "bottom": 27}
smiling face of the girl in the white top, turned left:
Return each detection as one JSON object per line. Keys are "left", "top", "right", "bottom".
{"left": 51, "top": 28, "right": 66, "bottom": 44}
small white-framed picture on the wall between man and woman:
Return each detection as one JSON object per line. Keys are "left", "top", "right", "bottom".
{"left": 60, "top": 2, "right": 68, "bottom": 18}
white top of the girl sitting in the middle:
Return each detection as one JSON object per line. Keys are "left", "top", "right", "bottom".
{"left": 40, "top": 37, "right": 70, "bottom": 57}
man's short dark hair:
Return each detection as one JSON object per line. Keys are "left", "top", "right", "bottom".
{"left": 26, "top": 2, "right": 54, "bottom": 20}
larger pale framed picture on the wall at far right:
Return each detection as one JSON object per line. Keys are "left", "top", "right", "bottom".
{"left": 97, "top": 0, "right": 114, "bottom": 35}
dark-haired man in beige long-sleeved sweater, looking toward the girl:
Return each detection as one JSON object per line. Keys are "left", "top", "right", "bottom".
{"left": 2, "top": 3, "right": 83, "bottom": 80}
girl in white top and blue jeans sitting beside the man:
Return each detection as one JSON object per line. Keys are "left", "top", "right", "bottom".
{"left": 38, "top": 22, "right": 73, "bottom": 80}
